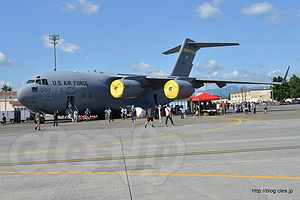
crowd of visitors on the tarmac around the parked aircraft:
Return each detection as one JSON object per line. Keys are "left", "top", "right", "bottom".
{"left": 28, "top": 101, "right": 267, "bottom": 130}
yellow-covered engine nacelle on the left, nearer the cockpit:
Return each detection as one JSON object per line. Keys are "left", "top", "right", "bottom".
{"left": 110, "top": 79, "right": 143, "bottom": 99}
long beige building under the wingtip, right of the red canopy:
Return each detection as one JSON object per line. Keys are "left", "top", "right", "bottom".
{"left": 230, "top": 89, "right": 272, "bottom": 103}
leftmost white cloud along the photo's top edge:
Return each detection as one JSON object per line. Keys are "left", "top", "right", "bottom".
{"left": 60, "top": 0, "right": 99, "bottom": 14}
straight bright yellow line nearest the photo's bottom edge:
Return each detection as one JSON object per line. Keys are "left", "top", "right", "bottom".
{"left": 0, "top": 172, "right": 300, "bottom": 180}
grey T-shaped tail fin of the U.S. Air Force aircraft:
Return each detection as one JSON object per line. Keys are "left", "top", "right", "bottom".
{"left": 163, "top": 38, "right": 239, "bottom": 77}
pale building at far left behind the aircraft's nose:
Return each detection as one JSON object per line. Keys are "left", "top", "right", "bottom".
{"left": 0, "top": 92, "right": 25, "bottom": 111}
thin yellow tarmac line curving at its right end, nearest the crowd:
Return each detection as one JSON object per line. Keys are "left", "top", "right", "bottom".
{"left": 0, "top": 119, "right": 242, "bottom": 156}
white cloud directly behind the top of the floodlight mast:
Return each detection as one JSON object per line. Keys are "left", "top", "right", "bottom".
{"left": 41, "top": 33, "right": 82, "bottom": 53}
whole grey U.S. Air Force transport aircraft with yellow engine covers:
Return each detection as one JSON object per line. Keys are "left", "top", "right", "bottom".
{"left": 17, "top": 38, "right": 288, "bottom": 118}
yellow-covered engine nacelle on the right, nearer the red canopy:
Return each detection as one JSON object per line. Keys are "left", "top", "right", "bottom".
{"left": 164, "top": 80, "right": 195, "bottom": 99}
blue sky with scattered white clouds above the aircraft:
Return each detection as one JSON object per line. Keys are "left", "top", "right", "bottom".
{"left": 0, "top": 0, "right": 300, "bottom": 91}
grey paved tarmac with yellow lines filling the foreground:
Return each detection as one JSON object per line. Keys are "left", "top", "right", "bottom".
{"left": 0, "top": 105, "right": 300, "bottom": 200}
